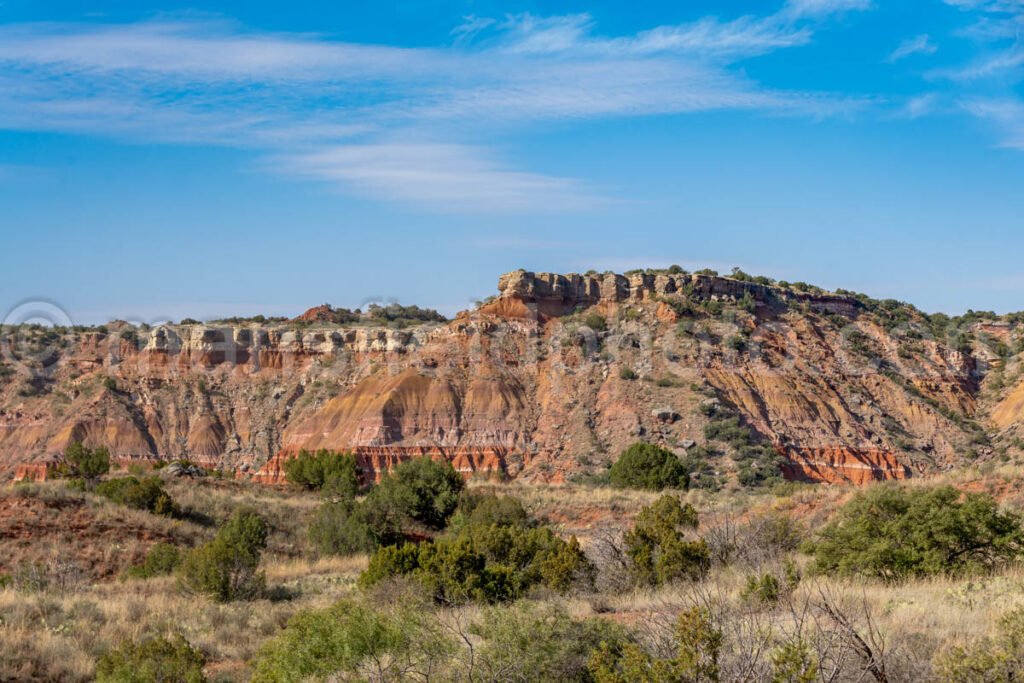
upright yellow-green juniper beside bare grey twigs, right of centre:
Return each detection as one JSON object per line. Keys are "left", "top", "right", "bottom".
{"left": 625, "top": 496, "right": 711, "bottom": 586}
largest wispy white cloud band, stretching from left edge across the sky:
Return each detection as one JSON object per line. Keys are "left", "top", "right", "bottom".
{"left": 0, "top": 10, "right": 868, "bottom": 211}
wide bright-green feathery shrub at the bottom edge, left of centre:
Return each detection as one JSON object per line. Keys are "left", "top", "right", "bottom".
{"left": 252, "top": 600, "right": 454, "bottom": 683}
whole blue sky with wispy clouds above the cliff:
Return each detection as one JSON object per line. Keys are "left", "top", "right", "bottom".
{"left": 0, "top": 0, "right": 1024, "bottom": 323}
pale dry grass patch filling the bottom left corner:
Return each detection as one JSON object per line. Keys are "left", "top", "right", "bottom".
{"left": 0, "top": 557, "right": 366, "bottom": 681}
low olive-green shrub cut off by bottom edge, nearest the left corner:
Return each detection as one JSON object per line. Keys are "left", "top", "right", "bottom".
{"left": 96, "top": 635, "right": 206, "bottom": 683}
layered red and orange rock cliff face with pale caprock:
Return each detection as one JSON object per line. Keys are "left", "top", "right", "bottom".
{"left": 0, "top": 270, "right": 1024, "bottom": 483}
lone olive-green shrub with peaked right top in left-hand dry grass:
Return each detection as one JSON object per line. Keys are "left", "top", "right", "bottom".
{"left": 177, "top": 508, "right": 267, "bottom": 602}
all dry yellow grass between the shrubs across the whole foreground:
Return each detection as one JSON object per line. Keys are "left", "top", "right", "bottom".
{"left": 6, "top": 473, "right": 1024, "bottom": 681}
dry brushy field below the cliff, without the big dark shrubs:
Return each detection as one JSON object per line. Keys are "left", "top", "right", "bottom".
{"left": 6, "top": 458, "right": 1024, "bottom": 681}
